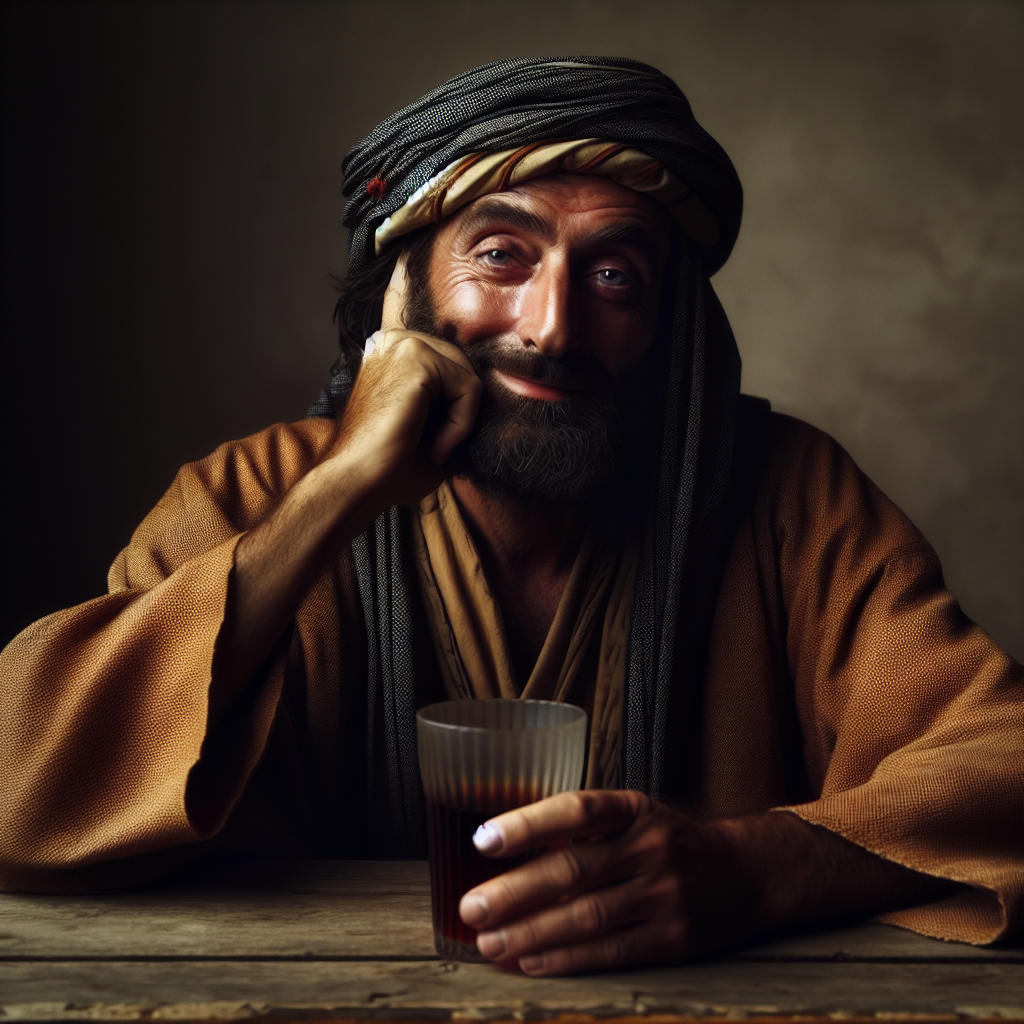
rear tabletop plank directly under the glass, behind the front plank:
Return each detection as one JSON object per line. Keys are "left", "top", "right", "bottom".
{"left": 0, "top": 861, "right": 1011, "bottom": 963}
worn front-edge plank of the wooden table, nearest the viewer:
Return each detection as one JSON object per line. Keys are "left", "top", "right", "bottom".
{"left": 0, "top": 962, "right": 1024, "bottom": 1021}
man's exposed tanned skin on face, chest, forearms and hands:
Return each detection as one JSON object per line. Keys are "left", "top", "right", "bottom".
{"left": 211, "top": 175, "right": 951, "bottom": 975}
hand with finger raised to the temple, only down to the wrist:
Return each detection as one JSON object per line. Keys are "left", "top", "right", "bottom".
{"left": 332, "top": 256, "right": 482, "bottom": 512}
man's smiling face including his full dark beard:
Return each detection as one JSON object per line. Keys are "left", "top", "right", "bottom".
{"left": 410, "top": 174, "right": 670, "bottom": 504}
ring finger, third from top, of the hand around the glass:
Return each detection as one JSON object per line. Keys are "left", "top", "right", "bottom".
{"left": 476, "top": 879, "right": 667, "bottom": 959}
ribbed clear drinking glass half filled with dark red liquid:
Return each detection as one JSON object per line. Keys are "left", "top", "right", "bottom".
{"left": 416, "top": 699, "right": 587, "bottom": 963}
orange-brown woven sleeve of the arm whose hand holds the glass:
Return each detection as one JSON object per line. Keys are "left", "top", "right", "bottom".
{"left": 769, "top": 418, "right": 1024, "bottom": 943}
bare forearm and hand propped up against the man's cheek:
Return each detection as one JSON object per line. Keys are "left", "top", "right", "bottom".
{"left": 211, "top": 251, "right": 483, "bottom": 716}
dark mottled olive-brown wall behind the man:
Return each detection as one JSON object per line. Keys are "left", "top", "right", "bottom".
{"left": 0, "top": 0, "right": 1024, "bottom": 656}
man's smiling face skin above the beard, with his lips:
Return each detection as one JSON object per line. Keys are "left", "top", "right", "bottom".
{"left": 429, "top": 174, "right": 670, "bottom": 389}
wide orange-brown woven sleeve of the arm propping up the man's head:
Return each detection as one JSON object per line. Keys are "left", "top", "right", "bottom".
{"left": 0, "top": 421, "right": 331, "bottom": 889}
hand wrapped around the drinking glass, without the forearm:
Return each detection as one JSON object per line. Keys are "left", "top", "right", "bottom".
{"left": 460, "top": 790, "right": 757, "bottom": 975}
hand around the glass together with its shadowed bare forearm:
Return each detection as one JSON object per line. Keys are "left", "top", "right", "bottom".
{"left": 460, "top": 791, "right": 951, "bottom": 976}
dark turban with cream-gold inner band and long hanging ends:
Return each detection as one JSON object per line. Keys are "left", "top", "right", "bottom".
{"left": 309, "top": 57, "right": 767, "bottom": 857}
